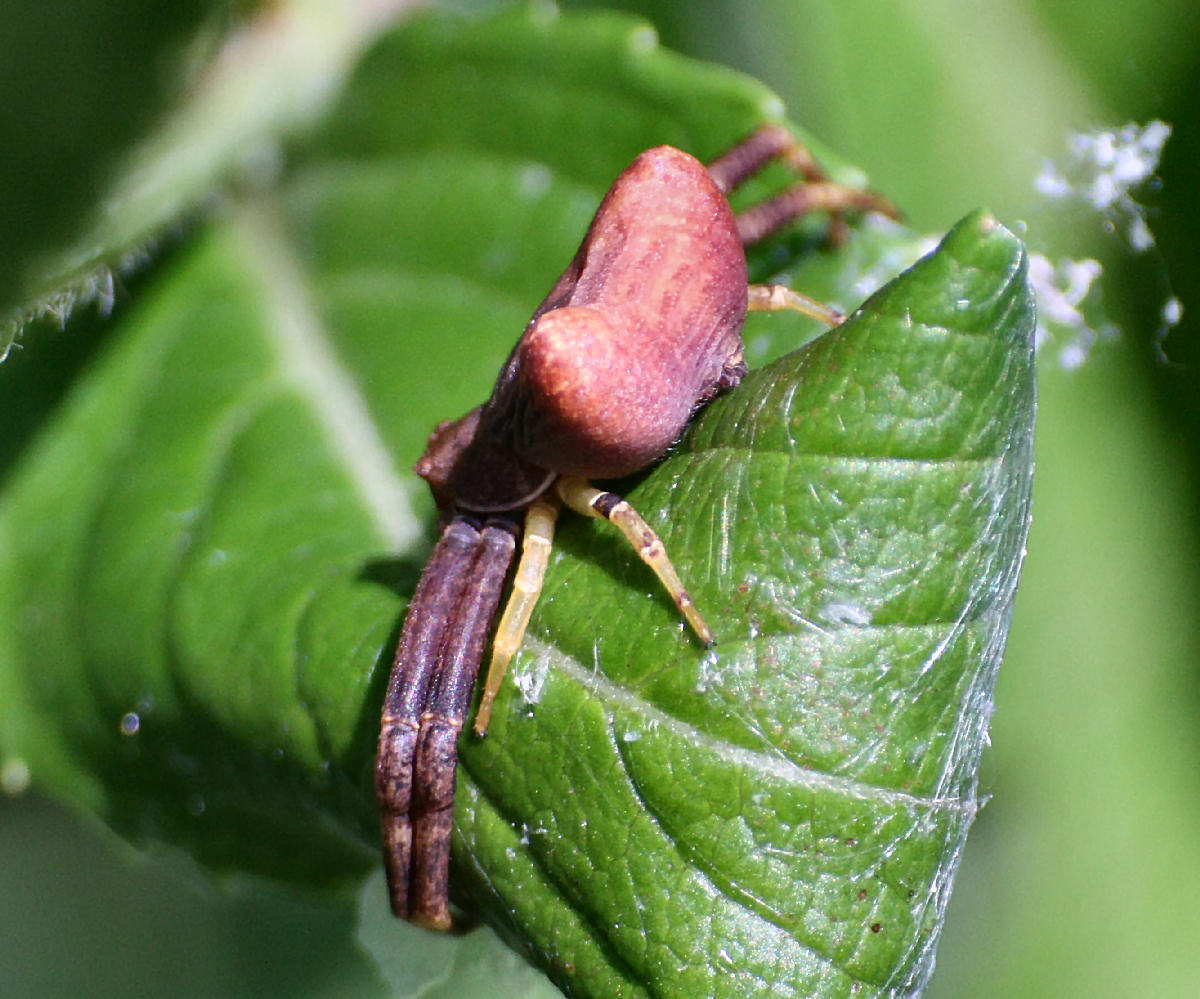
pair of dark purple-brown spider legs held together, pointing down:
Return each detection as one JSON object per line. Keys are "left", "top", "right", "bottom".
{"left": 376, "top": 516, "right": 518, "bottom": 929}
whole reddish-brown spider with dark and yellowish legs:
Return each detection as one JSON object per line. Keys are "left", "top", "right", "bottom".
{"left": 376, "top": 127, "right": 894, "bottom": 929}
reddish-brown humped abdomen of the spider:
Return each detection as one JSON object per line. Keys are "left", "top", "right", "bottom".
{"left": 481, "top": 146, "right": 746, "bottom": 478}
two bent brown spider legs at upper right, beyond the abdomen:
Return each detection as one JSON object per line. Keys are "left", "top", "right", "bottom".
{"left": 708, "top": 125, "right": 899, "bottom": 246}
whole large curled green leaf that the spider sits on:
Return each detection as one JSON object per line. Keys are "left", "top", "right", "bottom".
{"left": 0, "top": 7, "right": 1033, "bottom": 995}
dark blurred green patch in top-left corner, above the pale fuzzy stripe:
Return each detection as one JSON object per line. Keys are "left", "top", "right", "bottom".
{"left": 0, "top": 0, "right": 215, "bottom": 319}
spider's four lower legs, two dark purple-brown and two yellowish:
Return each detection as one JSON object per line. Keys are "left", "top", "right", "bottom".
{"left": 374, "top": 477, "right": 713, "bottom": 929}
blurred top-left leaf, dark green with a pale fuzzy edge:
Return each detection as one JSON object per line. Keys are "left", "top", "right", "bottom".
{"left": 0, "top": 0, "right": 414, "bottom": 360}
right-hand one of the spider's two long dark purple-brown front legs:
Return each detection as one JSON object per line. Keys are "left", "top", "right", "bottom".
{"left": 408, "top": 519, "right": 518, "bottom": 929}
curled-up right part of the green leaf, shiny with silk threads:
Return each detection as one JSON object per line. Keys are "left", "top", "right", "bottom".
{"left": 460, "top": 208, "right": 1033, "bottom": 995}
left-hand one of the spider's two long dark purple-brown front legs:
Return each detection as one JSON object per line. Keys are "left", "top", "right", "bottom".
{"left": 374, "top": 518, "right": 513, "bottom": 919}
